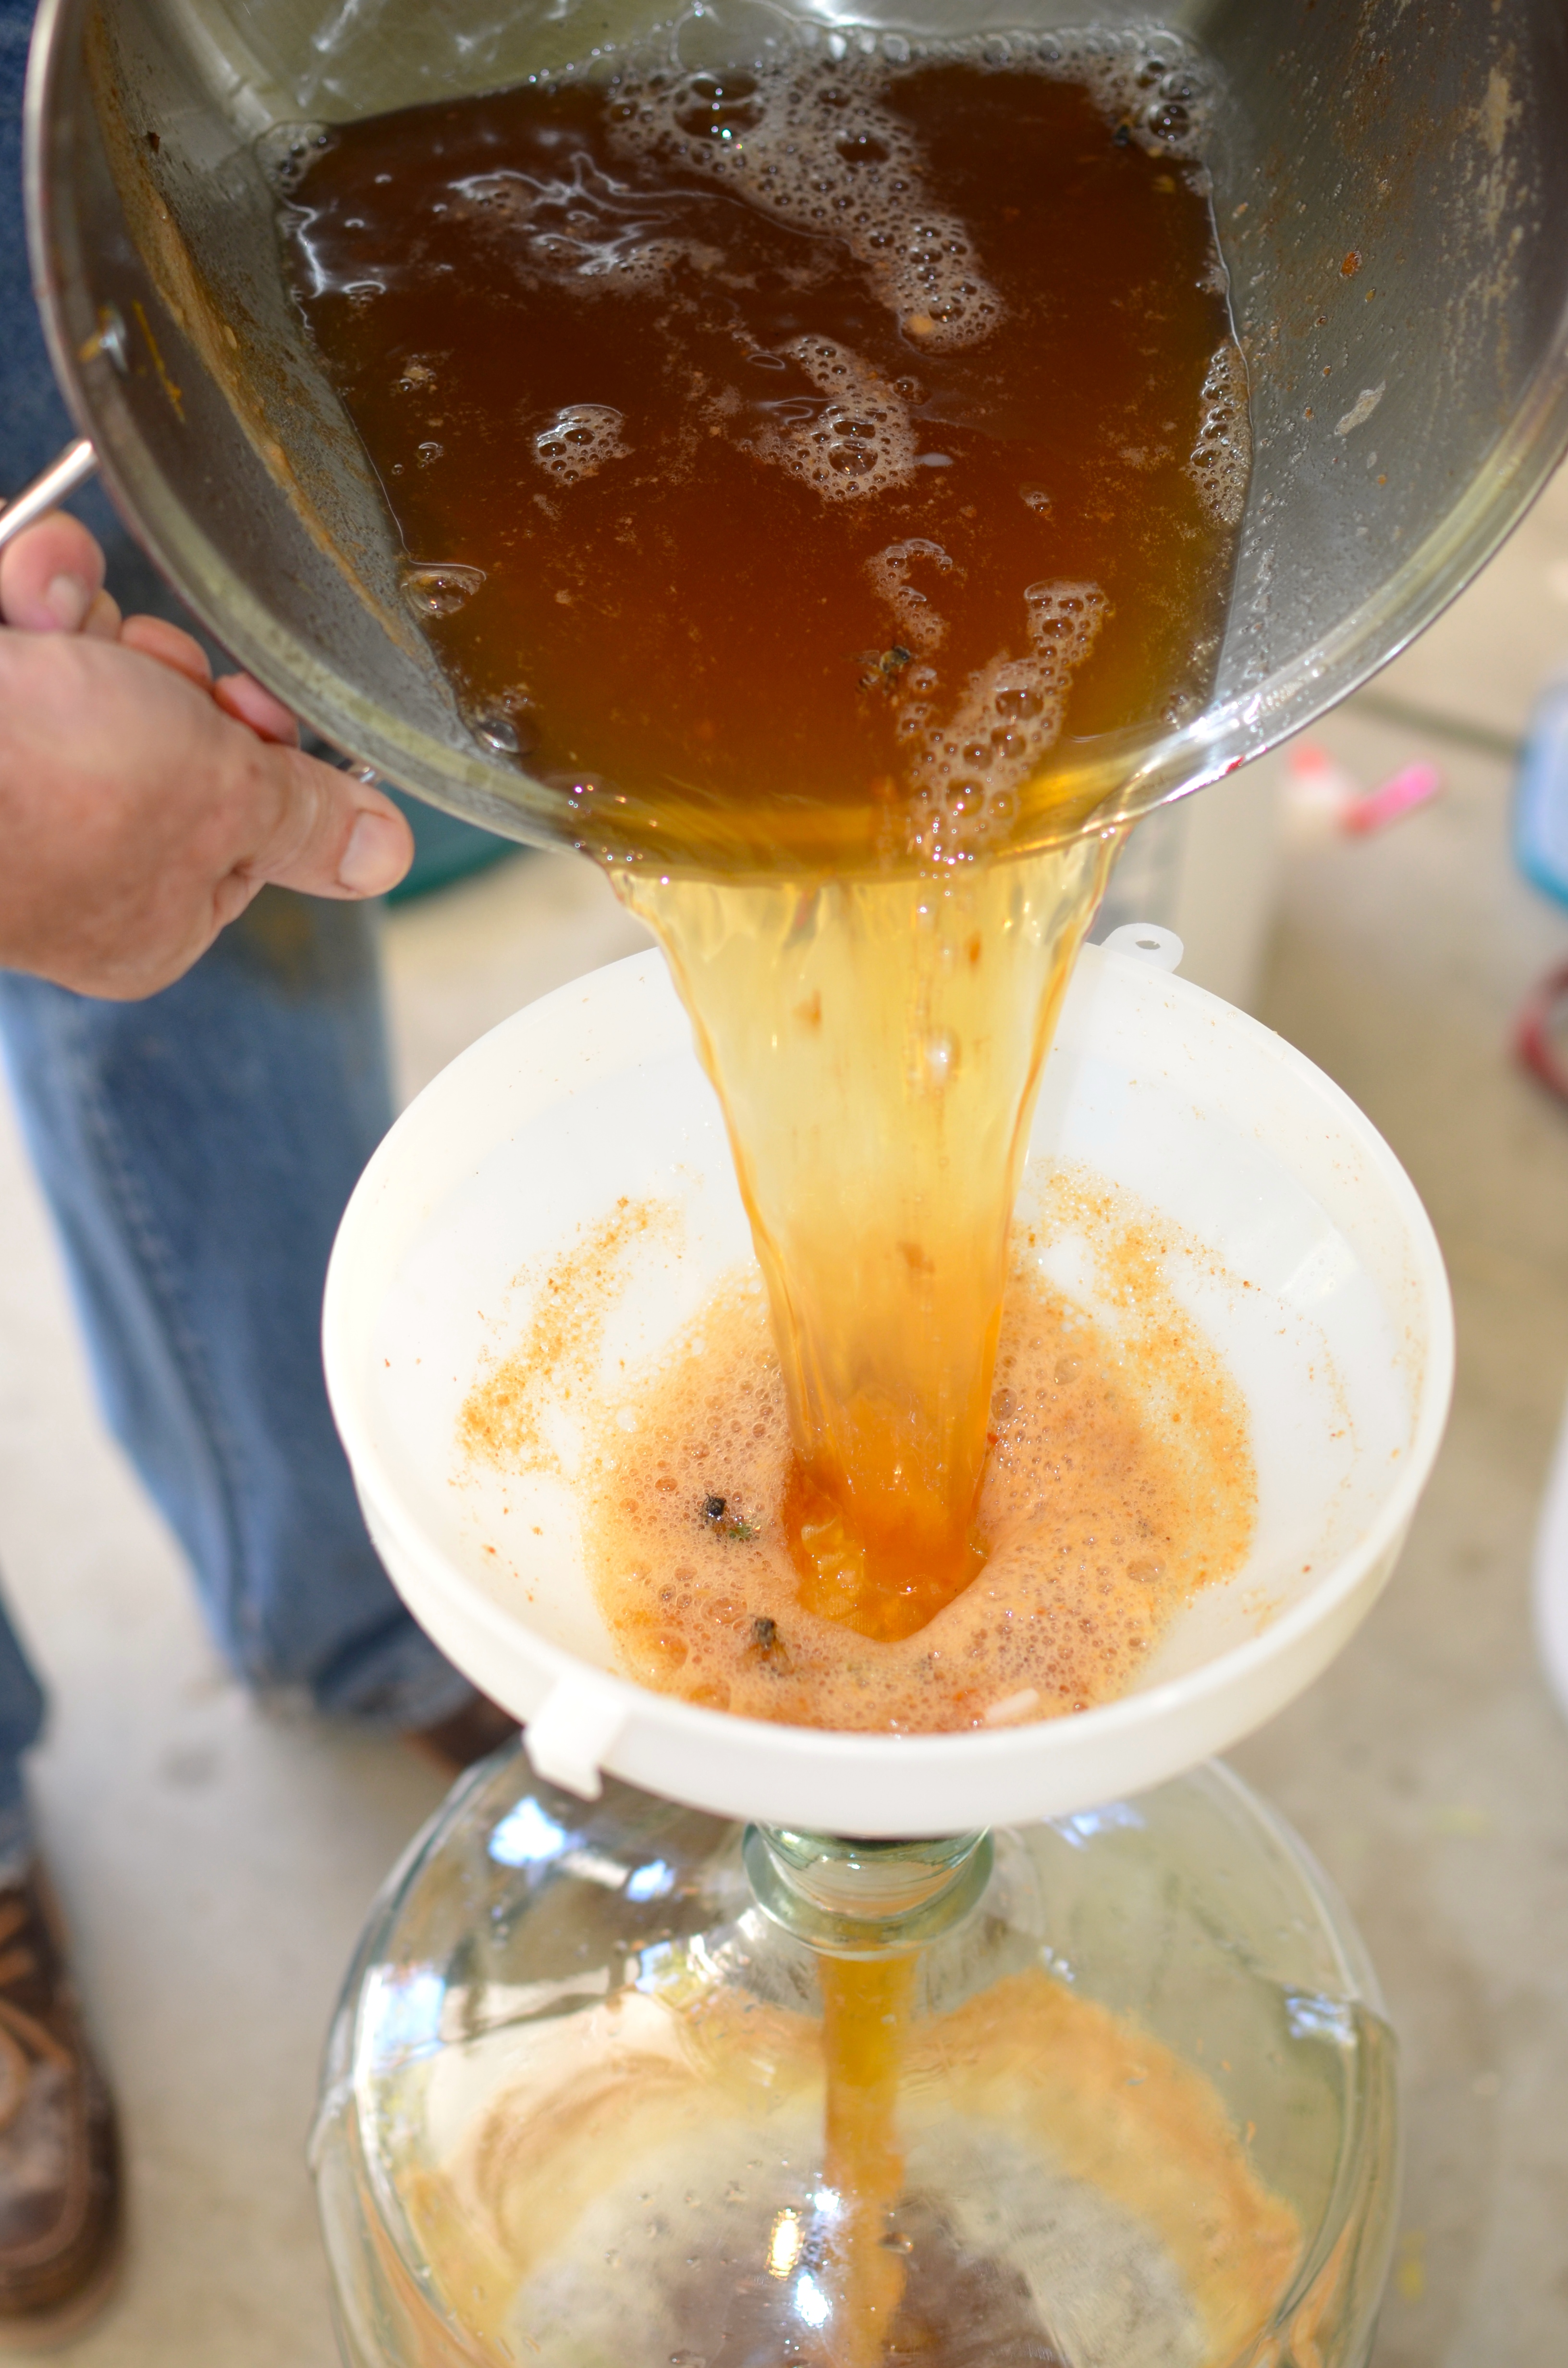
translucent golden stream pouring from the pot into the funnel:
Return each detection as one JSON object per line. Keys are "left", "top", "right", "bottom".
{"left": 623, "top": 836, "right": 1113, "bottom": 1639}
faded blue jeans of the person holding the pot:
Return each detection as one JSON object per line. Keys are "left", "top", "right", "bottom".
{"left": 0, "top": 0, "right": 471, "bottom": 1863}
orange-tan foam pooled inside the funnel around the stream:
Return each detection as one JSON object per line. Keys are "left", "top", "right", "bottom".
{"left": 578, "top": 1174, "right": 1255, "bottom": 1733}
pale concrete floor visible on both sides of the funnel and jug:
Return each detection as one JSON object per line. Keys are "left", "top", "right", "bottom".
{"left": 0, "top": 478, "right": 1568, "bottom": 2368}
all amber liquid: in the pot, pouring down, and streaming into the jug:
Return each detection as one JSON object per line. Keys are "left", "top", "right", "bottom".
{"left": 287, "top": 49, "right": 1246, "bottom": 2368}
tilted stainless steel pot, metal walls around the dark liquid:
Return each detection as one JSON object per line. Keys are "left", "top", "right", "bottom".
{"left": 12, "top": 0, "right": 1568, "bottom": 840}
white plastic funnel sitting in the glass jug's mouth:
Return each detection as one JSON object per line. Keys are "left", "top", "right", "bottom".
{"left": 324, "top": 931, "right": 1454, "bottom": 1838}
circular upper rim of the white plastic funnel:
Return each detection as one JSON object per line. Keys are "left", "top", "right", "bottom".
{"left": 322, "top": 947, "right": 1454, "bottom": 1833}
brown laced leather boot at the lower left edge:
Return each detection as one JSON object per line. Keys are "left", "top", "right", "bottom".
{"left": 0, "top": 1866, "right": 121, "bottom": 2352}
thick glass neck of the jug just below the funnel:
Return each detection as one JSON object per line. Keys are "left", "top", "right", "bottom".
{"left": 744, "top": 1825, "right": 992, "bottom": 1956}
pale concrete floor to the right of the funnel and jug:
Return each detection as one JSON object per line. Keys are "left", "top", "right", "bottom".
{"left": 1234, "top": 478, "right": 1568, "bottom": 2368}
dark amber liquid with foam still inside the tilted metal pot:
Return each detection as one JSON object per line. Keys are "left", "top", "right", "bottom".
{"left": 287, "top": 57, "right": 1237, "bottom": 874}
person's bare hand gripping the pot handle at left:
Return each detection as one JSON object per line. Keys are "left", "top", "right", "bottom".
{"left": 0, "top": 514, "right": 415, "bottom": 1002}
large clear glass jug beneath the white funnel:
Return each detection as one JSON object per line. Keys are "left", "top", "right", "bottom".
{"left": 313, "top": 1748, "right": 1397, "bottom": 2368}
